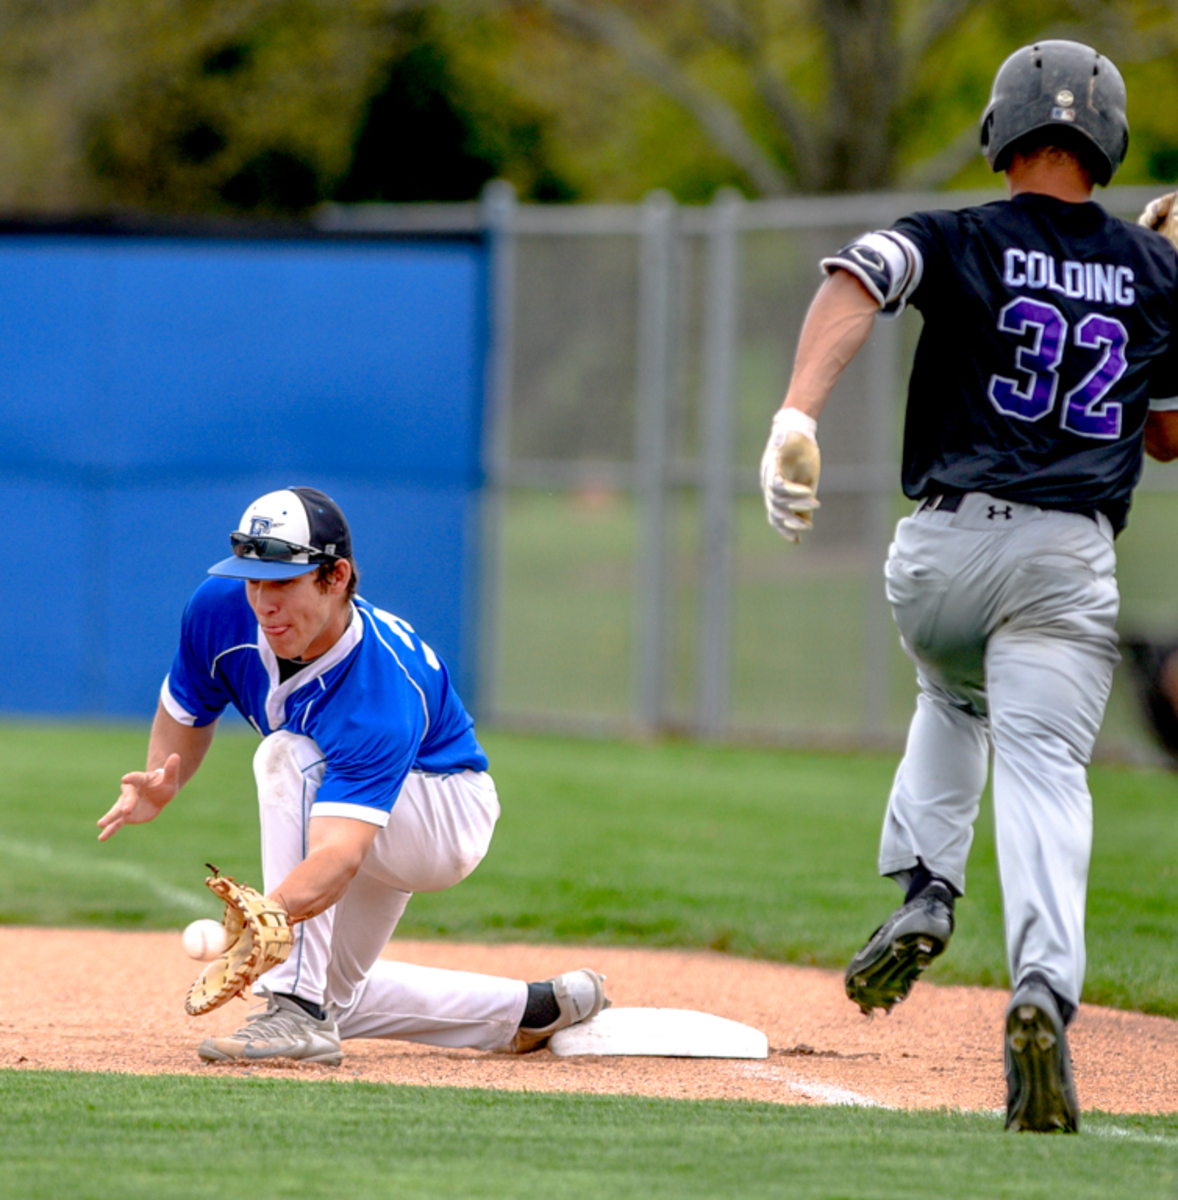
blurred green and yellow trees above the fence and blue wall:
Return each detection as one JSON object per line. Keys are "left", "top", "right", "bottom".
{"left": 0, "top": 0, "right": 1178, "bottom": 214}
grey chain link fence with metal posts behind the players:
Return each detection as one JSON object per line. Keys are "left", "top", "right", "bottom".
{"left": 323, "top": 184, "right": 1178, "bottom": 757}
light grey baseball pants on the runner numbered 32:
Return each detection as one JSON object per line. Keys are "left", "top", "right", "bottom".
{"left": 879, "top": 493, "right": 1119, "bottom": 1003}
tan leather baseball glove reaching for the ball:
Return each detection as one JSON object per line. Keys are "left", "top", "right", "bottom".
{"left": 184, "top": 863, "right": 294, "bottom": 1016}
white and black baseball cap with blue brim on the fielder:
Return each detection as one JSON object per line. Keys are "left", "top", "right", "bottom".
{"left": 209, "top": 487, "right": 351, "bottom": 580}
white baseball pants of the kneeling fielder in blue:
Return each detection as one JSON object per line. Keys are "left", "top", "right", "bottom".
{"left": 253, "top": 730, "right": 528, "bottom": 1050}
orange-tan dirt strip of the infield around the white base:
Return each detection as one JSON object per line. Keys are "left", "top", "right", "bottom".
{"left": 0, "top": 926, "right": 1178, "bottom": 1112}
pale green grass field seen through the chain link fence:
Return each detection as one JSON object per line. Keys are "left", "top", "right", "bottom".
{"left": 495, "top": 482, "right": 1178, "bottom": 758}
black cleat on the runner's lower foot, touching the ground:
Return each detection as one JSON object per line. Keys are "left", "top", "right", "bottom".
{"left": 1006, "top": 976, "right": 1080, "bottom": 1133}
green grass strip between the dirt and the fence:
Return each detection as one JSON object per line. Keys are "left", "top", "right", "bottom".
{"left": 0, "top": 724, "right": 1178, "bottom": 1015}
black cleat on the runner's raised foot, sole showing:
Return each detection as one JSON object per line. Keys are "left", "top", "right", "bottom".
{"left": 846, "top": 880, "right": 954, "bottom": 1016}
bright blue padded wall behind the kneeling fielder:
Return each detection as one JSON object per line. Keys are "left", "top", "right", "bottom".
{"left": 0, "top": 233, "right": 487, "bottom": 716}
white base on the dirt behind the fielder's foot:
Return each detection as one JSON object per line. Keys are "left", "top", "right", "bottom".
{"left": 548, "top": 1008, "right": 769, "bottom": 1058}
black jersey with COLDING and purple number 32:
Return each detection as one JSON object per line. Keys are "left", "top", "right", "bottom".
{"left": 894, "top": 193, "right": 1178, "bottom": 529}
